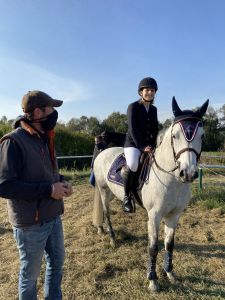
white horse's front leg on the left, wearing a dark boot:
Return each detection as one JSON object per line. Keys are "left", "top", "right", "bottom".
{"left": 148, "top": 212, "right": 160, "bottom": 292}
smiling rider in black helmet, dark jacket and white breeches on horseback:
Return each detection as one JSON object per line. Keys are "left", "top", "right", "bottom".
{"left": 123, "top": 77, "right": 158, "bottom": 213}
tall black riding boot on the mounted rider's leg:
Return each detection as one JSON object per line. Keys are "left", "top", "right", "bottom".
{"left": 122, "top": 167, "right": 134, "bottom": 213}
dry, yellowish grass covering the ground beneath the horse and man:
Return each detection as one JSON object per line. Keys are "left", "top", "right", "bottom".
{"left": 0, "top": 181, "right": 225, "bottom": 300}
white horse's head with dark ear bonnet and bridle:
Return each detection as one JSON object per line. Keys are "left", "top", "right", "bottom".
{"left": 171, "top": 97, "right": 209, "bottom": 182}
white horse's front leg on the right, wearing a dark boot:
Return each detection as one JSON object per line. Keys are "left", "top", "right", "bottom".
{"left": 163, "top": 214, "right": 180, "bottom": 283}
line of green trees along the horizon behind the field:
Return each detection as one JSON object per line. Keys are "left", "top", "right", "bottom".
{"left": 0, "top": 104, "right": 225, "bottom": 156}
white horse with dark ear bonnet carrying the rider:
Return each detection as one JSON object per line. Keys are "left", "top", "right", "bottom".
{"left": 93, "top": 97, "right": 209, "bottom": 291}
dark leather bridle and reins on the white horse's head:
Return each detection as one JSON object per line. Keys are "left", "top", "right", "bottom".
{"left": 152, "top": 117, "right": 202, "bottom": 173}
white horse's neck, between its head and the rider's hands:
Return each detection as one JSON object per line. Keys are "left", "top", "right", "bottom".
{"left": 155, "top": 127, "right": 175, "bottom": 170}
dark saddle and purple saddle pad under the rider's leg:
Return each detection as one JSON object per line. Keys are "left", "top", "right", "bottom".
{"left": 107, "top": 152, "right": 153, "bottom": 207}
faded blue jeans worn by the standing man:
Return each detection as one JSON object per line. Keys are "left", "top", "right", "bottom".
{"left": 13, "top": 217, "right": 65, "bottom": 300}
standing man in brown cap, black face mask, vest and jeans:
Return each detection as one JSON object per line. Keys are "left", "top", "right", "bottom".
{"left": 0, "top": 91, "right": 72, "bottom": 300}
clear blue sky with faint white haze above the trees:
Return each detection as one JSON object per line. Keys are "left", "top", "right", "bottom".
{"left": 0, "top": 0, "right": 225, "bottom": 122}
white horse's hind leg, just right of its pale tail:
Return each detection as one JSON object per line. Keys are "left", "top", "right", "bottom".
{"left": 100, "top": 188, "right": 115, "bottom": 247}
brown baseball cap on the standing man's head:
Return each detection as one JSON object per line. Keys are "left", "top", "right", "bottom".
{"left": 22, "top": 91, "right": 63, "bottom": 113}
